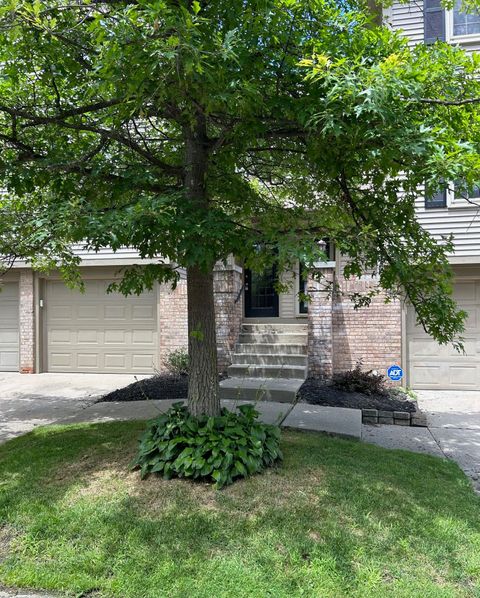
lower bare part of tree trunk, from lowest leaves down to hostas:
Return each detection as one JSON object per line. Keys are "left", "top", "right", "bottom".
{"left": 187, "top": 267, "right": 220, "bottom": 417}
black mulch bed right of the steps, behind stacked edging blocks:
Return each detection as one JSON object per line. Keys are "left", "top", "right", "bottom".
{"left": 298, "top": 378, "right": 416, "bottom": 413}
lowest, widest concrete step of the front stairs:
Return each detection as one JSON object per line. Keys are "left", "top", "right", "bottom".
{"left": 219, "top": 378, "right": 303, "bottom": 403}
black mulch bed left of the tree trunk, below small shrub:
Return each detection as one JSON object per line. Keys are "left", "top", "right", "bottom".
{"left": 100, "top": 374, "right": 188, "bottom": 403}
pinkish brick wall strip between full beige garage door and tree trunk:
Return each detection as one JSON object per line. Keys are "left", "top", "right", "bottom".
{"left": 157, "top": 278, "right": 188, "bottom": 370}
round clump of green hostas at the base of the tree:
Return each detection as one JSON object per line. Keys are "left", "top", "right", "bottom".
{"left": 133, "top": 403, "right": 282, "bottom": 488}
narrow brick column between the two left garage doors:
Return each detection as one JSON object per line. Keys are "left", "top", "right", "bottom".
{"left": 19, "top": 270, "right": 35, "bottom": 374}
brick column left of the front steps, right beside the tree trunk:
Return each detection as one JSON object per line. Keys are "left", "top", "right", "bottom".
{"left": 213, "top": 259, "right": 243, "bottom": 372}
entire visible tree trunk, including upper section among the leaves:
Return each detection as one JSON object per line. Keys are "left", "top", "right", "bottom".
{"left": 184, "top": 113, "right": 220, "bottom": 417}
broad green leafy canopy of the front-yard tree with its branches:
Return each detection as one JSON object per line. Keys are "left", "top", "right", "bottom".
{"left": 0, "top": 0, "right": 480, "bottom": 412}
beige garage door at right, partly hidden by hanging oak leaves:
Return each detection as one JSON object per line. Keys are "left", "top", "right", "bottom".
{"left": 407, "top": 280, "right": 480, "bottom": 390}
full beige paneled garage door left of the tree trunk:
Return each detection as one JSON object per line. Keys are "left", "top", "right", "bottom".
{"left": 44, "top": 280, "right": 158, "bottom": 373}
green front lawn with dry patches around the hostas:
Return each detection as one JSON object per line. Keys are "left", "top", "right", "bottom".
{"left": 0, "top": 422, "right": 480, "bottom": 598}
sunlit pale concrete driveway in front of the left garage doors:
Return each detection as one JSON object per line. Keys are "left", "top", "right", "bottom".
{"left": 0, "top": 372, "right": 145, "bottom": 442}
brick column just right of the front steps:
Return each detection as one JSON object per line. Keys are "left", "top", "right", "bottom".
{"left": 307, "top": 267, "right": 334, "bottom": 379}
